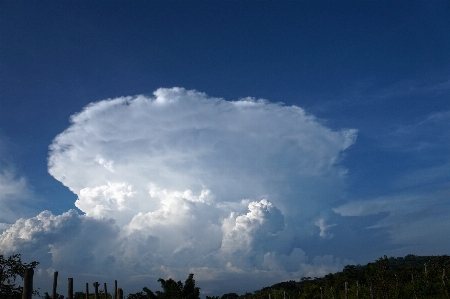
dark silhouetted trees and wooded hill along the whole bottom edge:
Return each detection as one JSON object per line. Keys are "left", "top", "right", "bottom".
{"left": 0, "top": 254, "right": 450, "bottom": 299}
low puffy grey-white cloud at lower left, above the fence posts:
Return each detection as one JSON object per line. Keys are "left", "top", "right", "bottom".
{"left": 0, "top": 210, "right": 123, "bottom": 291}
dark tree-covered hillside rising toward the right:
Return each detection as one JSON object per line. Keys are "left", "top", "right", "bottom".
{"left": 206, "top": 254, "right": 450, "bottom": 299}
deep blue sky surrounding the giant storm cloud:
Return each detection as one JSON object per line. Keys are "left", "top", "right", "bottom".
{"left": 0, "top": 1, "right": 450, "bottom": 296}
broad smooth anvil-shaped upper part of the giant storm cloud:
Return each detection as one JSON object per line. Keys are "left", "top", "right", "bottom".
{"left": 49, "top": 88, "right": 355, "bottom": 222}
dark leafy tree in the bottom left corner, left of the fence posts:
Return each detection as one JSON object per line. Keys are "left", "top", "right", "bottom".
{"left": 0, "top": 253, "right": 39, "bottom": 299}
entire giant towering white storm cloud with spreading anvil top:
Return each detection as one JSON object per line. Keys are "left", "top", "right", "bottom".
{"left": 0, "top": 88, "right": 356, "bottom": 296}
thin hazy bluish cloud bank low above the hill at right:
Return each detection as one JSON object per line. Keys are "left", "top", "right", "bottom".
{"left": 333, "top": 190, "right": 450, "bottom": 255}
